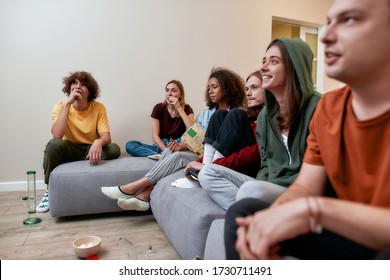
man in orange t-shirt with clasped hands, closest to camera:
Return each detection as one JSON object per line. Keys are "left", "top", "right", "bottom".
{"left": 225, "top": 0, "right": 390, "bottom": 259}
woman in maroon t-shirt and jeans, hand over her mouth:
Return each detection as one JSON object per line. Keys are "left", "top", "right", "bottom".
{"left": 126, "top": 80, "right": 195, "bottom": 157}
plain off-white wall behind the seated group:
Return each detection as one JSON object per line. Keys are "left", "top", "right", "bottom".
{"left": 0, "top": 0, "right": 336, "bottom": 184}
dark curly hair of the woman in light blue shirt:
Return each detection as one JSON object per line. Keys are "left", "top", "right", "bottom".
{"left": 205, "top": 67, "right": 248, "bottom": 109}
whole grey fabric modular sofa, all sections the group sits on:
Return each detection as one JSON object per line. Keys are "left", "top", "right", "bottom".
{"left": 49, "top": 154, "right": 225, "bottom": 259}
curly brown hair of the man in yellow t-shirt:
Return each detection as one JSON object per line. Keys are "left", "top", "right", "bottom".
{"left": 62, "top": 71, "right": 100, "bottom": 102}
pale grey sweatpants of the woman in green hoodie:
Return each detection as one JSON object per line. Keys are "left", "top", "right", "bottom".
{"left": 198, "top": 164, "right": 286, "bottom": 210}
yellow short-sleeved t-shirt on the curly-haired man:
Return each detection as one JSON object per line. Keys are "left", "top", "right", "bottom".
{"left": 52, "top": 101, "right": 110, "bottom": 144}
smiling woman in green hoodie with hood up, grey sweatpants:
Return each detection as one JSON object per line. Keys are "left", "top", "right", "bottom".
{"left": 198, "top": 38, "right": 321, "bottom": 210}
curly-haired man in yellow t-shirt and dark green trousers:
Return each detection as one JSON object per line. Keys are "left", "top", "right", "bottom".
{"left": 36, "top": 71, "right": 120, "bottom": 212}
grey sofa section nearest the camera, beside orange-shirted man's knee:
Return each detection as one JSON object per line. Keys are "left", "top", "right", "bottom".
{"left": 204, "top": 219, "right": 226, "bottom": 260}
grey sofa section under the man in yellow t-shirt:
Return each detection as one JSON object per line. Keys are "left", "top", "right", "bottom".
{"left": 49, "top": 155, "right": 156, "bottom": 217}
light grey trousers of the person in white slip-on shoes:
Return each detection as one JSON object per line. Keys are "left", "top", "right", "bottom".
{"left": 145, "top": 149, "right": 198, "bottom": 185}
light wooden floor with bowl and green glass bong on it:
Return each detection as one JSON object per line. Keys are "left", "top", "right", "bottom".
{"left": 0, "top": 190, "right": 180, "bottom": 260}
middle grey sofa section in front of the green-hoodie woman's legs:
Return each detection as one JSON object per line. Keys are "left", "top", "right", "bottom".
{"left": 150, "top": 170, "right": 226, "bottom": 259}
